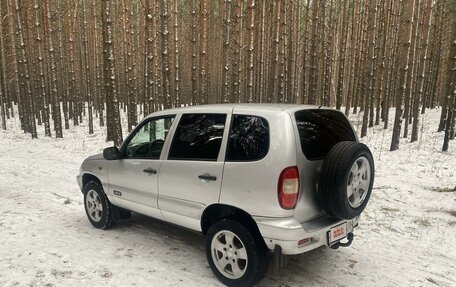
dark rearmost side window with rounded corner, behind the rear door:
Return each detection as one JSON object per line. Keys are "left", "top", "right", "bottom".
{"left": 226, "top": 115, "right": 269, "bottom": 161}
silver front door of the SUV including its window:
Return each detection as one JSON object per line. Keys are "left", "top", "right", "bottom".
{"left": 108, "top": 116, "right": 174, "bottom": 218}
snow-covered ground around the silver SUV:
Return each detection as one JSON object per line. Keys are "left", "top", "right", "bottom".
{"left": 0, "top": 107, "right": 456, "bottom": 286}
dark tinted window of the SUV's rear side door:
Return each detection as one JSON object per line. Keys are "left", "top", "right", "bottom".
{"left": 169, "top": 114, "right": 226, "bottom": 161}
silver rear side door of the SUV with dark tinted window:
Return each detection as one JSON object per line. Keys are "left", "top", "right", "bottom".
{"left": 158, "top": 113, "right": 229, "bottom": 230}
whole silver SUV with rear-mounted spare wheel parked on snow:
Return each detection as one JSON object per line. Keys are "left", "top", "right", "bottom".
{"left": 77, "top": 104, "right": 374, "bottom": 286}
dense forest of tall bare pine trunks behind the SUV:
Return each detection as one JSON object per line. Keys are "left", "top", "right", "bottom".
{"left": 0, "top": 0, "right": 456, "bottom": 150}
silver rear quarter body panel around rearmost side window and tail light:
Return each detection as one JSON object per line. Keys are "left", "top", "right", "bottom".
{"left": 220, "top": 108, "right": 296, "bottom": 217}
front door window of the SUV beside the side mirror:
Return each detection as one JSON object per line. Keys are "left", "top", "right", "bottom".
{"left": 124, "top": 116, "right": 174, "bottom": 159}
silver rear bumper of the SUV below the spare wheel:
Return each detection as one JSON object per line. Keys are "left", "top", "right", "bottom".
{"left": 253, "top": 216, "right": 359, "bottom": 255}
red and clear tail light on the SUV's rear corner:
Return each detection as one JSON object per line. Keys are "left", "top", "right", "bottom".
{"left": 277, "top": 166, "right": 299, "bottom": 209}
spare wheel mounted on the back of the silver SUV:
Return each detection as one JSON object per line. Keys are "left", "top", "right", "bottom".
{"left": 318, "top": 141, "right": 375, "bottom": 219}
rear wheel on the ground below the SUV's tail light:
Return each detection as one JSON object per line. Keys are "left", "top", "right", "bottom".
{"left": 206, "top": 222, "right": 268, "bottom": 287}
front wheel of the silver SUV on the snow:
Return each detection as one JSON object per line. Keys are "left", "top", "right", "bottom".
{"left": 84, "top": 181, "right": 114, "bottom": 229}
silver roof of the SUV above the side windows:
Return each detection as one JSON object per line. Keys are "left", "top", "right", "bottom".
{"left": 147, "top": 104, "right": 328, "bottom": 117}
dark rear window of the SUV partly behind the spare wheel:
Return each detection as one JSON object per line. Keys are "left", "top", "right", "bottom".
{"left": 295, "top": 110, "right": 356, "bottom": 160}
